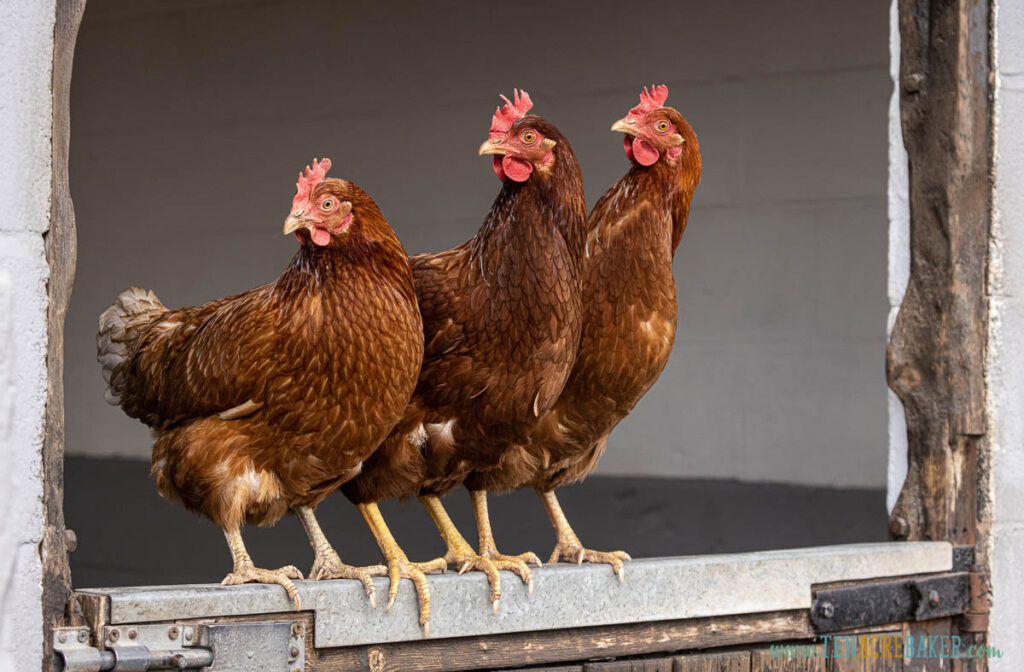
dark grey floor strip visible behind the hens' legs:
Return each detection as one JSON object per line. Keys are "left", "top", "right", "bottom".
{"left": 65, "top": 457, "right": 887, "bottom": 588}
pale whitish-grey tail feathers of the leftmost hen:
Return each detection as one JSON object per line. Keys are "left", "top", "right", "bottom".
{"left": 96, "top": 287, "right": 167, "bottom": 406}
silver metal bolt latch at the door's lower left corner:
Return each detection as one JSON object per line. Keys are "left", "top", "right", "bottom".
{"left": 53, "top": 621, "right": 306, "bottom": 672}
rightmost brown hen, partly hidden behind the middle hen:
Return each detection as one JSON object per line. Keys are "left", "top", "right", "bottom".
{"left": 466, "top": 86, "right": 700, "bottom": 581}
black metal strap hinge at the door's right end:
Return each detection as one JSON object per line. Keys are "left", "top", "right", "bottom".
{"left": 810, "top": 572, "right": 971, "bottom": 632}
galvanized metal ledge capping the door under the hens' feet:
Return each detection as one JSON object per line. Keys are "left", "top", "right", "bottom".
{"left": 78, "top": 542, "right": 952, "bottom": 648}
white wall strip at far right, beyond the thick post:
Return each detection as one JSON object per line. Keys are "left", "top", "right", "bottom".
{"left": 988, "top": 0, "right": 1024, "bottom": 659}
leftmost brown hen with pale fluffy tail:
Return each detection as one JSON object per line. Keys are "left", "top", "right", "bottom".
{"left": 97, "top": 159, "right": 423, "bottom": 608}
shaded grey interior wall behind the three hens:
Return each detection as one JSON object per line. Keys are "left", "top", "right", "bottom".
{"left": 67, "top": 0, "right": 891, "bottom": 487}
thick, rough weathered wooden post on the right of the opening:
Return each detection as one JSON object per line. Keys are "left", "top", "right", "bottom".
{"left": 886, "top": 0, "right": 992, "bottom": 655}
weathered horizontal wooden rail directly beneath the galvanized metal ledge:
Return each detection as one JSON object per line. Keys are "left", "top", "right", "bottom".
{"left": 309, "top": 610, "right": 814, "bottom": 672}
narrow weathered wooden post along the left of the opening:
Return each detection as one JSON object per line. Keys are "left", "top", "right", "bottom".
{"left": 40, "top": 0, "right": 85, "bottom": 671}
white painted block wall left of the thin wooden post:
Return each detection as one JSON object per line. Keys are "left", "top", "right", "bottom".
{"left": 0, "top": 0, "right": 54, "bottom": 670}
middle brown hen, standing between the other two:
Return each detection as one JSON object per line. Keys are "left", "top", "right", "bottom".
{"left": 343, "top": 92, "right": 587, "bottom": 625}
